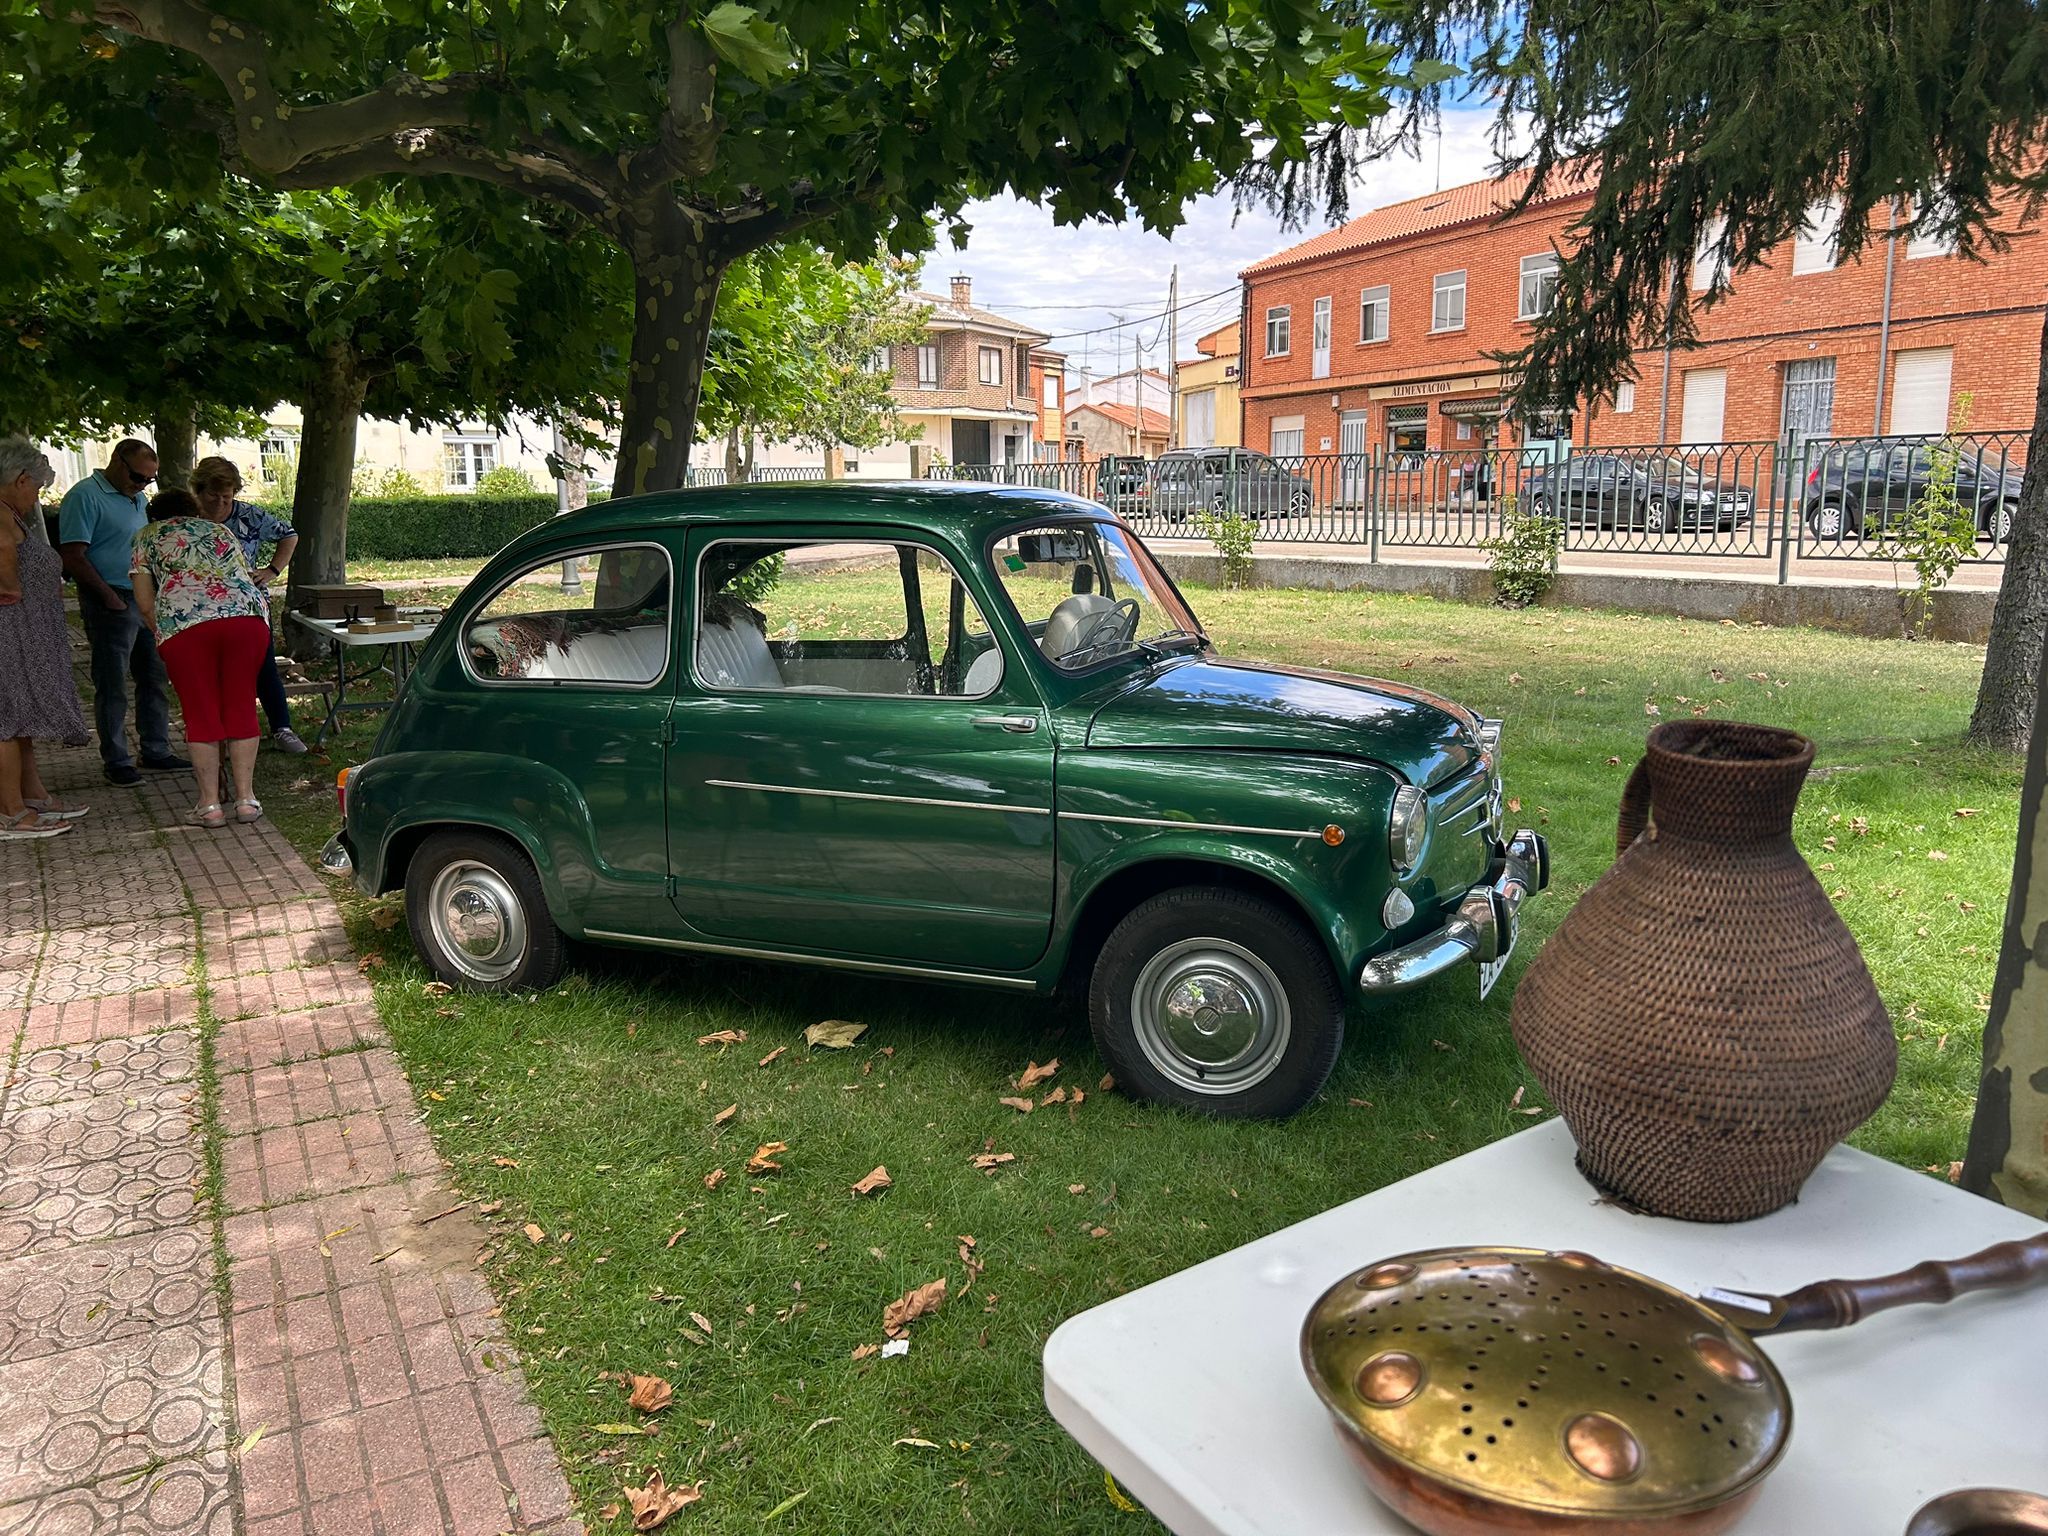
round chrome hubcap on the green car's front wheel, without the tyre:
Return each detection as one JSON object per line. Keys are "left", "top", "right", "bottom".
{"left": 1130, "top": 938, "right": 1288, "bottom": 1094}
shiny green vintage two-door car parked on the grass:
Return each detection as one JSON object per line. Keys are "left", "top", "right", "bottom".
{"left": 326, "top": 481, "right": 1548, "bottom": 1116}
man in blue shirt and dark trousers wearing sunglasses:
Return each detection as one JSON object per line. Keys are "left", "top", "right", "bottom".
{"left": 57, "top": 438, "right": 193, "bottom": 784}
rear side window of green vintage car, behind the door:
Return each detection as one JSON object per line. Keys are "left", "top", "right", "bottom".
{"left": 463, "top": 545, "right": 674, "bottom": 688}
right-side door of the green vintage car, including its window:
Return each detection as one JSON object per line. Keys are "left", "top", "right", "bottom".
{"left": 668, "top": 528, "right": 1055, "bottom": 971}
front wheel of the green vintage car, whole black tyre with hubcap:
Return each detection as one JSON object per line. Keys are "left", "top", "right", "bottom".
{"left": 1087, "top": 887, "right": 1343, "bottom": 1120}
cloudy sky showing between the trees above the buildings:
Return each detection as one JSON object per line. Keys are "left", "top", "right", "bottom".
{"left": 922, "top": 113, "right": 1493, "bottom": 373}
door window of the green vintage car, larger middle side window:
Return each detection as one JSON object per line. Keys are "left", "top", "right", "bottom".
{"left": 692, "top": 539, "right": 1004, "bottom": 698}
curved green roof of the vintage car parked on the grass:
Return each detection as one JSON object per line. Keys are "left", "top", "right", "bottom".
{"left": 514, "top": 479, "right": 1114, "bottom": 545}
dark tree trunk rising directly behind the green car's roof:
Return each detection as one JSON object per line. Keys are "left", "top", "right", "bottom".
{"left": 612, "top": 207, "right": 723, "bottom": 496}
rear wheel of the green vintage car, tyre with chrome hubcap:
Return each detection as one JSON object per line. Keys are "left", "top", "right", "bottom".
{"left": 406, "top": 829, "right": 563, "bottom": 991}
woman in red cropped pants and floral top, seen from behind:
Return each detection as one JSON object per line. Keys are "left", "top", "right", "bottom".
{"left": 133, "top": 492, "right": 270, "bottom": 827}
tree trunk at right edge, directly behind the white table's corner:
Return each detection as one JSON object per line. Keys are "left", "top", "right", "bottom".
{"left": 1962, "top": 626, "right": 2048, "bottom": 1217}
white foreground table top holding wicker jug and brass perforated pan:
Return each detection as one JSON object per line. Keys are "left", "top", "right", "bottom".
{"left": 1044, "top": 1120, "right": 2048, "bottom": 1536}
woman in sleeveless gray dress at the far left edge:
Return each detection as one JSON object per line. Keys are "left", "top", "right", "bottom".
{"left": 0, "top": 436, "right": 92, "bottom": 842}
